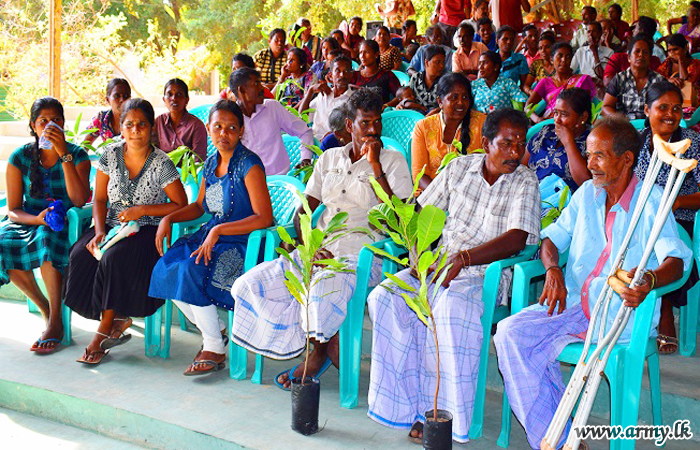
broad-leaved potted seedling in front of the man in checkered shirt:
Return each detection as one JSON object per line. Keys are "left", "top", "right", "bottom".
{"left": 367, "top": 168, "right": 452, "bottom": 449}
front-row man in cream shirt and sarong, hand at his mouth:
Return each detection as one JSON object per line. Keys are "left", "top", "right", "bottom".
{"left": 231, "top": 88, "right": 412, "bottom": 390}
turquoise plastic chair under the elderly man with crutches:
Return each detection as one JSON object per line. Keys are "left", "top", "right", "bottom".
{"left": 498, "top": 226, "right": 696, "bottom": 449}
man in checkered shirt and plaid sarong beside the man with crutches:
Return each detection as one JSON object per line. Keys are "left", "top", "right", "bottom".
{"left": 367, "top": 109, "right": 540, "bottom": 442}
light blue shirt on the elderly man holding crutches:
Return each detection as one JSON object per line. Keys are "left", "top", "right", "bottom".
{"left": 534, "top": 176, "right": 692, "bottom": 343}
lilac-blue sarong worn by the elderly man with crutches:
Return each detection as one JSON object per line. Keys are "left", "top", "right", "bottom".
{"left": 493, "top": 304, "right": 589, "bottom": 449}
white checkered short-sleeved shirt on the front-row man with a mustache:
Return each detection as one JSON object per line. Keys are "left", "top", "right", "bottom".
{"left": 418, "top": 154, "right": 540, "bottom": 275}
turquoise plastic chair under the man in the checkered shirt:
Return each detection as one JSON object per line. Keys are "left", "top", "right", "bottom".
{"left": 340, "top": 239, "right": 538, "bottom": 439}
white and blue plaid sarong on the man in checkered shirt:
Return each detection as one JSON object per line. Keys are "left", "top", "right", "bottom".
{"left": 367, "top": 269, "right": 484, "bottom": 442}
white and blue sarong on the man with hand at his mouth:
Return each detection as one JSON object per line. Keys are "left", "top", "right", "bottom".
{"left": 231, "top": 250, "right": 381, "bottom": 359}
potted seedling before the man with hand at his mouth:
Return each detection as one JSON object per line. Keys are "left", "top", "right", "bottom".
{"left": 276, "top": 192, "right": 370, "bottom": 436}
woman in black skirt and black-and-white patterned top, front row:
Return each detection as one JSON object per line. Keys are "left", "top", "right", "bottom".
{"left": 66, "top": 98, "right": 187, "bottom": 364}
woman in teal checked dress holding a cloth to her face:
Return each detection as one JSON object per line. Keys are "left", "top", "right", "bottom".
{"left": 0, "top": 97, "right": 90, "bottom": 353}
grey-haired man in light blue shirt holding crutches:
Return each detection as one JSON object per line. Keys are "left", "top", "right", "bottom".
{"left": 494, "top": 116, "right": 692, "bottom": 449}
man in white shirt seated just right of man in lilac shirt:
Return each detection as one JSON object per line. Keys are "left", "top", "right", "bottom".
{"left": 299, "top": 56, "right": 353, "bottom": 144}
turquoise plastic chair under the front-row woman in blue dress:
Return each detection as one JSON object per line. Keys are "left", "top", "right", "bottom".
{"left": 146, "top": 175, "right": 304, "bottom": 364}
